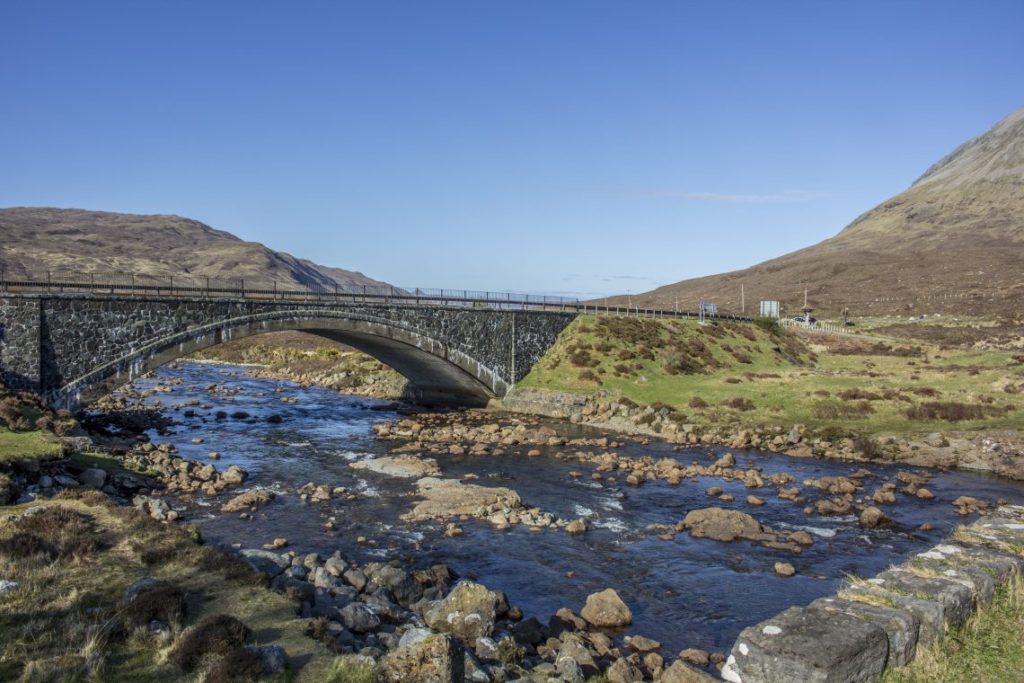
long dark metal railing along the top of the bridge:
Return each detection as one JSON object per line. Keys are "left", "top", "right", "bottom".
{"left": 0, "top": 269, "right": 752, "bottom": 323}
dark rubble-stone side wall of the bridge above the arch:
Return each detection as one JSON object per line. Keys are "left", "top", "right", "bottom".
{"left": 0, "top": 296, "right": 573, "bottom": 401}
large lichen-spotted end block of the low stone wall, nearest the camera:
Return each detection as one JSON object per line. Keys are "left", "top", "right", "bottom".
{"left": 722, "top": 607, "right": 889, "bottom": 683}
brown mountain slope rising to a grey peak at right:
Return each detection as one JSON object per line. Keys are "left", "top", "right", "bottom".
{"left": 616, "top": 109, "right": 1024, "bottom": 316}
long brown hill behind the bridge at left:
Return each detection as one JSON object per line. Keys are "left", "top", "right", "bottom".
{"left": 0, "top": 208, "right": 384, "bottom": 289}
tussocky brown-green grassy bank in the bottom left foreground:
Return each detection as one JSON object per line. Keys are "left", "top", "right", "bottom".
{"left": 0, "top": 493, "right": 345, "bottom": 681}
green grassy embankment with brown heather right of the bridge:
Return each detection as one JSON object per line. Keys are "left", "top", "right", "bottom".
{"left": 518, "top": 316, "right": 1024, "bottom": 435}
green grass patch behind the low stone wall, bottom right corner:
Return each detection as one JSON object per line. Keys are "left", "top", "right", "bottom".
{"left": 882, "top": 579, "right": 1024, "bottom": 683}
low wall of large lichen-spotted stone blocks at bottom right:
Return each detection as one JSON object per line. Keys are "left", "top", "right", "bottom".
{"left": 722, "top": 506, "right": 1024, "bottom": 683}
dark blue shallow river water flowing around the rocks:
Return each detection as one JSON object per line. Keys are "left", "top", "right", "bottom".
{"left": 116, "top": 362, "right": 1024, "bottom": 652}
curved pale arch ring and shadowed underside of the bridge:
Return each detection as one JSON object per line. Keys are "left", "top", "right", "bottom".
{"left": 50, "top": 310, "right": 503, "bottom": 408}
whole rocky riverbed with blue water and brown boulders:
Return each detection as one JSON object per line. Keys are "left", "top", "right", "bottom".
{"left": 24, "top": 364, "right": 1024, "bottom": 680}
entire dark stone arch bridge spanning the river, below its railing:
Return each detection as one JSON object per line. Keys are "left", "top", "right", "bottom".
{"left": 0, "top": 294, "right": 575, "bottom": 409}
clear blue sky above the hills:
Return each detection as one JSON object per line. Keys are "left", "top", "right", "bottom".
{"left": 0, "top": 0, "right": 1024, "bottom": 296}
